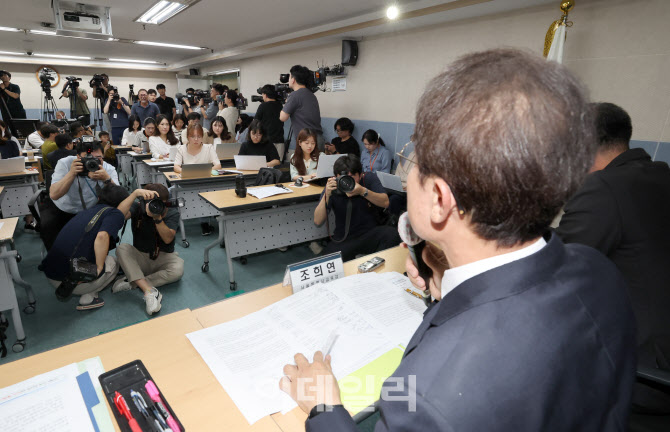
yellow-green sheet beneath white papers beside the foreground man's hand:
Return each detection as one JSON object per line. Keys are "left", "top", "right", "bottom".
{"left": 338, "top": 348, "right": 404, "bottom": 415}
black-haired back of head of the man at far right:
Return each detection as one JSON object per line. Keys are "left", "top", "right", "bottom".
{"left": 591, "top": 102, "right": 633, "bottom": 152}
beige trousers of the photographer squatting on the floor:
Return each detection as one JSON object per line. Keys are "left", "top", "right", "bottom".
{"left": 116, "top": 243, "right": 184, "bottom": 288}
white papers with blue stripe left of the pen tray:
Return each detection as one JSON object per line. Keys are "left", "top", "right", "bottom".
{"left": 0, "top": 357, "right": 114, "bottom": 432}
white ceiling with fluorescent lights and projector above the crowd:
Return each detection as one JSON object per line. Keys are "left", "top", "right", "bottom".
{"left": 0, "top": 0, "right": 560, "bottom": 69}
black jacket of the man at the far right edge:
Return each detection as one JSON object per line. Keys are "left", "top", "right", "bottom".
{"left": 556, "top": 148, "right": 670, "bottom": 368}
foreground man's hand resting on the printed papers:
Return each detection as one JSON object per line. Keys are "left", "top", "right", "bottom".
{"left": 279, "top": 351, "right": 342, "bottom": 414}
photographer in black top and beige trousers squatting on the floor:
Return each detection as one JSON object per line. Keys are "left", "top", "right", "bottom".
{"left": 112, "top": 184, "right": 184, "bottom": 315}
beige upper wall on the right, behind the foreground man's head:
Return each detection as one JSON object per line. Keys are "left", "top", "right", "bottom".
{"left": 197, "top": 0, "right": 670, "bottom": 141}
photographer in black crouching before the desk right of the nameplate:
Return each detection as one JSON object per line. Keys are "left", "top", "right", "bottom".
{"left": 314, "top": 155, "right": 401, "bottom": 261}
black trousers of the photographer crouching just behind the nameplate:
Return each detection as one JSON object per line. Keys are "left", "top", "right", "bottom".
{"left": 323, "top": 225, "right": 402, "bottom": 261}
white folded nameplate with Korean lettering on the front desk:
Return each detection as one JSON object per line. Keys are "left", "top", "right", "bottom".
{"left": 283, "top": 252, "right": 344, "bottom": 294}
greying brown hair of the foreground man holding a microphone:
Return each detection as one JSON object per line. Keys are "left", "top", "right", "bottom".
{"left": 415, "top": 49, "right": 596, "bottom": 247}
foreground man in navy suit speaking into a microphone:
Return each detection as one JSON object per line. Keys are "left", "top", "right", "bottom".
{"left": 280, "top": 50, "right": 635, "bottom": 432}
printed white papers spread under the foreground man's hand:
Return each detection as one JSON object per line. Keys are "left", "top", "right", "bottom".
{"left": 187, "top": 273, "right": 425, "bottom": 424}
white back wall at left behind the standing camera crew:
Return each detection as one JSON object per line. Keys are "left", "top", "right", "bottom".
{"left": 0, "top": 63, "right": 177, "bottom": 114}
